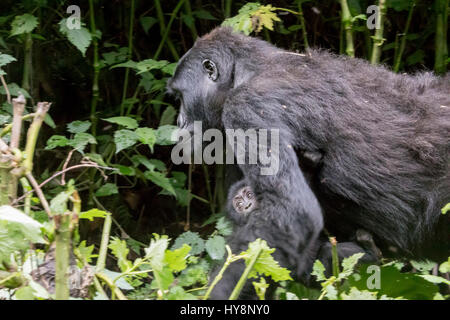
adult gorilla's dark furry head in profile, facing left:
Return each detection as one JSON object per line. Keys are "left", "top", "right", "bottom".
{"left": 167, "top": 27, "right": 272, "bottom": 131}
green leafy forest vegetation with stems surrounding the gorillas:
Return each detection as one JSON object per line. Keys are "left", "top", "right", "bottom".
{"left": 0, "top": 0, "right": 450, "bottom": 300}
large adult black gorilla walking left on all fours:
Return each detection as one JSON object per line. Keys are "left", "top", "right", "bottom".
{"left": 168, "top": 28, "right": 450, "bottom": 299}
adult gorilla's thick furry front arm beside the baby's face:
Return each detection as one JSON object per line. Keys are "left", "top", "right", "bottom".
{"left": 211, "top": 95, "right": 323, "bottom": 299}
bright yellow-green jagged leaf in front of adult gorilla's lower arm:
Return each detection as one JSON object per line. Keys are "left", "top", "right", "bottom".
{"left": 241, "top": 239, "right": 292, "bottom": 282}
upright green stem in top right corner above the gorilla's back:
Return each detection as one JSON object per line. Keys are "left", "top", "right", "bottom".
{"left": 434, "top": 0, "right": 449, "bottom": 74}
